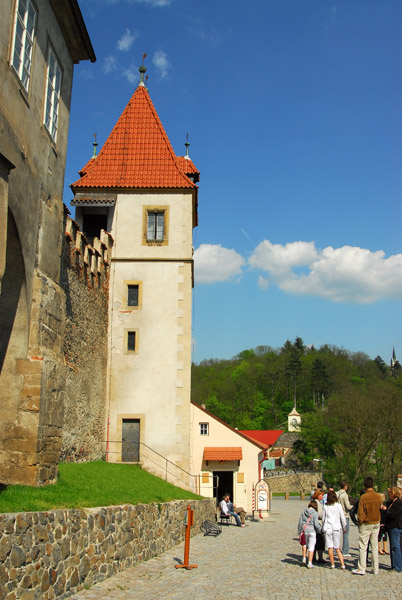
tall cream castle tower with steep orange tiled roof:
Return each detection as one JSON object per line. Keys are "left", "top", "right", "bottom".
{"left": 71, "top": 66, "right": 199, "bottom": 486}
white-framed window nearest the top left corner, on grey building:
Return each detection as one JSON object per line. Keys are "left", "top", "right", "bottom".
{"left": 11, "top": 0, "right": 37, "bottom": 92}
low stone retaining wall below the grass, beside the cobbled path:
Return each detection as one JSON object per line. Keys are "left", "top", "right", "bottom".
{"left": 0, "top": 499, "right": 215, "bottom": 600}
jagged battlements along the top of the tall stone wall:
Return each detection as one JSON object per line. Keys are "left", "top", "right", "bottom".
{"left": 64, "top": 206, "right": 113, "bottom": 284}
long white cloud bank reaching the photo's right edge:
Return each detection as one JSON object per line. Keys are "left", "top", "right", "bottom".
{"left": 249, "top": 240, "right": 402, "bottom": 303}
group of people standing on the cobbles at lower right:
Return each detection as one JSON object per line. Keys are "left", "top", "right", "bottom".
{"left": 298, "top": 477, "right": 402, "bottom": 575}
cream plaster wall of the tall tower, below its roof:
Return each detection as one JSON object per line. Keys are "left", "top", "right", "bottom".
{"left": 108, "top": 193, "right": 192, "bottom": 485}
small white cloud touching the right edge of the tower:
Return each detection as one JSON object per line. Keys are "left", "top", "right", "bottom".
{"left": 194, "top": 244, "right": 245, "bottom": 283}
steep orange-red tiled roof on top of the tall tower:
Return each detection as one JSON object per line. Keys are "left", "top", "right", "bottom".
{"left": 71, "top": 86, "right": 198, "bottom": 191}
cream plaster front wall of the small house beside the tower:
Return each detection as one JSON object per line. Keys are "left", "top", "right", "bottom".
{"left": 191, "top": 404, "right": 262, "bottom": 512}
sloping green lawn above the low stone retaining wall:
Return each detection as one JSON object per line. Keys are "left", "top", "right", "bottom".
{"left": 0, "top": 462, "right": 200, "bottom": 513}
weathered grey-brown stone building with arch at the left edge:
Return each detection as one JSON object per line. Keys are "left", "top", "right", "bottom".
{"left": 0, "top": 0, "right": 95, "bottom": 484}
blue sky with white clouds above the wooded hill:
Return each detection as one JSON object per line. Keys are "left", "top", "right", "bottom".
{"left": 64, "top": 0, "right": 402, "bottom": 362}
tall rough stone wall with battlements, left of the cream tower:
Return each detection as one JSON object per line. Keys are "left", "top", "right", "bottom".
{"left": 61, "top": 216, "right": 112, "bottom": 461}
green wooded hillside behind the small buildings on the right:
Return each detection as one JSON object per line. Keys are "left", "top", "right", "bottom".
{"left": 192, "top": 337, "right": 402, "bottom": 492}
